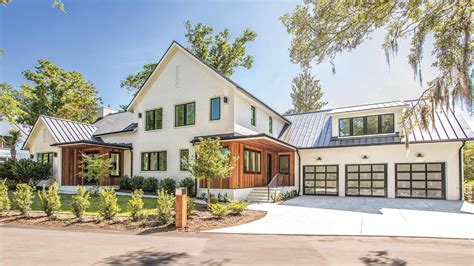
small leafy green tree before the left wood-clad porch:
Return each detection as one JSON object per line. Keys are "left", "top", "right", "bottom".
{"left": 78, "top": 153, "right": 112, "bottom": 186}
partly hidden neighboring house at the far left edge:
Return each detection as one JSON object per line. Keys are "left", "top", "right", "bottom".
{"left": 0, "top": 113, "right": 31, "bottom": 163}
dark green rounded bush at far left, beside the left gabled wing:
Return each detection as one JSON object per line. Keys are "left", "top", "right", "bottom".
{"left": 12, "top": 159, "right": 51, "bottom": 185}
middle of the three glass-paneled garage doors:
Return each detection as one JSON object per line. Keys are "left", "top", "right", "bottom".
{"left": 346, "top": 164, "right": 387, "bottom": 197}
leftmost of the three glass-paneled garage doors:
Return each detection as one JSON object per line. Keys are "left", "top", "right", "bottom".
{"left": 303, "top": 165, "right": 339, "bottom": 196}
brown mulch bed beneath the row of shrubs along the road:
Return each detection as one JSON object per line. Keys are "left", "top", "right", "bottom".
{"left": 0, "top": 205, "right": 266, "bottom": 234}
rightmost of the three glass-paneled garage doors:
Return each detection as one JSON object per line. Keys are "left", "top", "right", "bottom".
{"left": 395, "top": 163, "right": 445, "bottom": 199}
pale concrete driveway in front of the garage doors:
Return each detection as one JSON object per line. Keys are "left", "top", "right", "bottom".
{"left": 211, "top": 196, "right": 474, "bottom": 239}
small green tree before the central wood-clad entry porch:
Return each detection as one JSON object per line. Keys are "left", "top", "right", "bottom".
{"left": 185, "top": 138, "right": 238, "bottom": 204}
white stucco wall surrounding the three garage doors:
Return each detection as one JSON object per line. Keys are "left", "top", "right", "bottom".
{"left": 299, "top": 142, "right": 462, "bottom": 200}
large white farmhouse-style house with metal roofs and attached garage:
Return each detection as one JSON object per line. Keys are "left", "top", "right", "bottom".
{"left": 25, "top": 42, "right": 474, "bottom": 200}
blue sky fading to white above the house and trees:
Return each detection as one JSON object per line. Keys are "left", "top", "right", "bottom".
{"left": 0, "top": 0, "right": 435, "bottom": 112}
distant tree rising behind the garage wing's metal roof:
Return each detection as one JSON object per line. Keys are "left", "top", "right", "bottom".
{"left": 286, "top": 68, "right": 328, "bottom": 114}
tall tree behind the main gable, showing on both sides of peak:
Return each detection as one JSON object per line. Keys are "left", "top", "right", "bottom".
{"left": 120, "top": 21, "right": 257, "bottom": 93}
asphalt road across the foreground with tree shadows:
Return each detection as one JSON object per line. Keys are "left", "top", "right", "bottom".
{"left": 0, "top": 225, "right": 474, "bottom": 265}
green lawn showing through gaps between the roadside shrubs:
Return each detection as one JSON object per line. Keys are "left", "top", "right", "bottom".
{"left": 10, "top": 192, "right": 156, "bottom": 215}
